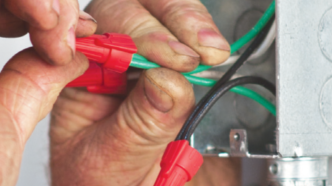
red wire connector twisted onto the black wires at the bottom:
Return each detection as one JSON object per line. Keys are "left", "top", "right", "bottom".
{"left": 154, "top": 140, "right": 203, "bottom": 186}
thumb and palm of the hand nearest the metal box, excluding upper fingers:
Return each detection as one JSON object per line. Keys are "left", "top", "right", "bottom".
{"left": 50, "top": 68, "right": 240, "bottom": 186}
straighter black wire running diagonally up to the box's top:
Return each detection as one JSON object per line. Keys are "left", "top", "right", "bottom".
{"left": 175, "top": 15, "right": 275, "bottom": 140}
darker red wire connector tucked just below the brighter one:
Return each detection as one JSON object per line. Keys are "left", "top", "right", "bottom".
{"left": 66, "top": 62, "right": 127, "bottom": 94}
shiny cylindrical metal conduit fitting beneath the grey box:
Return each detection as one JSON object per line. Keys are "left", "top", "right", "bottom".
{"left": 267, "top": 157, "right": 328, "bottom": 186}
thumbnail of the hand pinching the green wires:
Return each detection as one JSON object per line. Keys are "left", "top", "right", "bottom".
{"left": 144, "top": 76, "right": 173, "bottom": 112}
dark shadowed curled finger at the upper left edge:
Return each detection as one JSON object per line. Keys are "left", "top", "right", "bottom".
{"left": 0, "top": 4, "right": 28, "bottom": 37}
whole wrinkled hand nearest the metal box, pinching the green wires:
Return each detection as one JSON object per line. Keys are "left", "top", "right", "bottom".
{"left": 51, "top": 0, "right": 241, "bottom": 186}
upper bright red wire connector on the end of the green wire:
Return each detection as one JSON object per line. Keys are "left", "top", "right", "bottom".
{"left": 76, "top": 33, "right": 137, "bottom": 73}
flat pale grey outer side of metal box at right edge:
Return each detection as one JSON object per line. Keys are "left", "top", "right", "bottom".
{"left": 277, "top": 0, "right": 332, "bottom": 157}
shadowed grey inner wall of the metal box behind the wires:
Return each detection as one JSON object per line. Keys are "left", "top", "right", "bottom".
{"left": 192, "top": 0, "right": 276, "bottom": 157}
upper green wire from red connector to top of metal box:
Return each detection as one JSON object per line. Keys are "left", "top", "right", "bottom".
{"left": 130, "top": 0, "right": 275, "bottom": 74}
